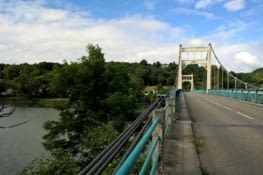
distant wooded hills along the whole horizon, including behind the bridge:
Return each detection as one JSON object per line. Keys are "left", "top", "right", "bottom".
{"left": 0, "top": 60, "right": 263, "bottom": 98}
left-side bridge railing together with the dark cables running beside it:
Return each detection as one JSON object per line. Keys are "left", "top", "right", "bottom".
{"left": 79, "top": 89, "right": 181, "bottom": 175}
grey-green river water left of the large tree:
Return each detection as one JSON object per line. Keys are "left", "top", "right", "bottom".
{"left": 0, "top": 107, "right": 59, "bottom": 175}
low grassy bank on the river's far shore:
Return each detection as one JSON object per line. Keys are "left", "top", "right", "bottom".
{"left": 5, "top": 97, "right": 68, "bottom": 108}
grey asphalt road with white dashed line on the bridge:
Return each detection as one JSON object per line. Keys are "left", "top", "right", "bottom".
{"left": 185, "top": 93, "right": 263, "bottom": 175}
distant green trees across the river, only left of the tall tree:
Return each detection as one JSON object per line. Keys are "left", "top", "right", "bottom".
{"left": 1, "top": 62, "right": 60, "bottom": 98}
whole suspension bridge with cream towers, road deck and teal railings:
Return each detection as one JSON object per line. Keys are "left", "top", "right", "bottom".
{"left": 79, "top": 44, "right": 263, "bottom": 175}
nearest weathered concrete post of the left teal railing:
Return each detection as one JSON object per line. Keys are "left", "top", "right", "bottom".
{"left": 152, "top": 108, "right": 165, "bottom": 175}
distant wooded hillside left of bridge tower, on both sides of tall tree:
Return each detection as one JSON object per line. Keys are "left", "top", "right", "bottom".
{"left": 0, "top": 60, "right": 177, "bottom": 98}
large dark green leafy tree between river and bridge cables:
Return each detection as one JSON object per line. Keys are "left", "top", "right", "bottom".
{"left": 39, "top": 45, "right": 141, "bottom": 173}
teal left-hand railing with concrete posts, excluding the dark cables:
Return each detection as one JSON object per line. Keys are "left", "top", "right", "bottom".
{"left": 116, "top": 89, "right": 181, "bottom": 175}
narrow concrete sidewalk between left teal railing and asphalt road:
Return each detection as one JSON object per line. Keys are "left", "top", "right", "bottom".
{"left": 164, "top": 94, "right": 201, "bottom": 175}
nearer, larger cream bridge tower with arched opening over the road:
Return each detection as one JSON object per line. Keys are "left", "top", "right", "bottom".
{"left": 176, "top": 43, "right": 212, "bottom": 92}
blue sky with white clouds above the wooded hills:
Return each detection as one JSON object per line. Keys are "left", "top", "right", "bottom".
{"left": 0, "top": 0, "right": 263, "bottom": 72}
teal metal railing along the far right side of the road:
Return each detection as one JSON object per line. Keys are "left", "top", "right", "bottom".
{"left": 194, "top": 89, "right": 263, "bottom": 104}
